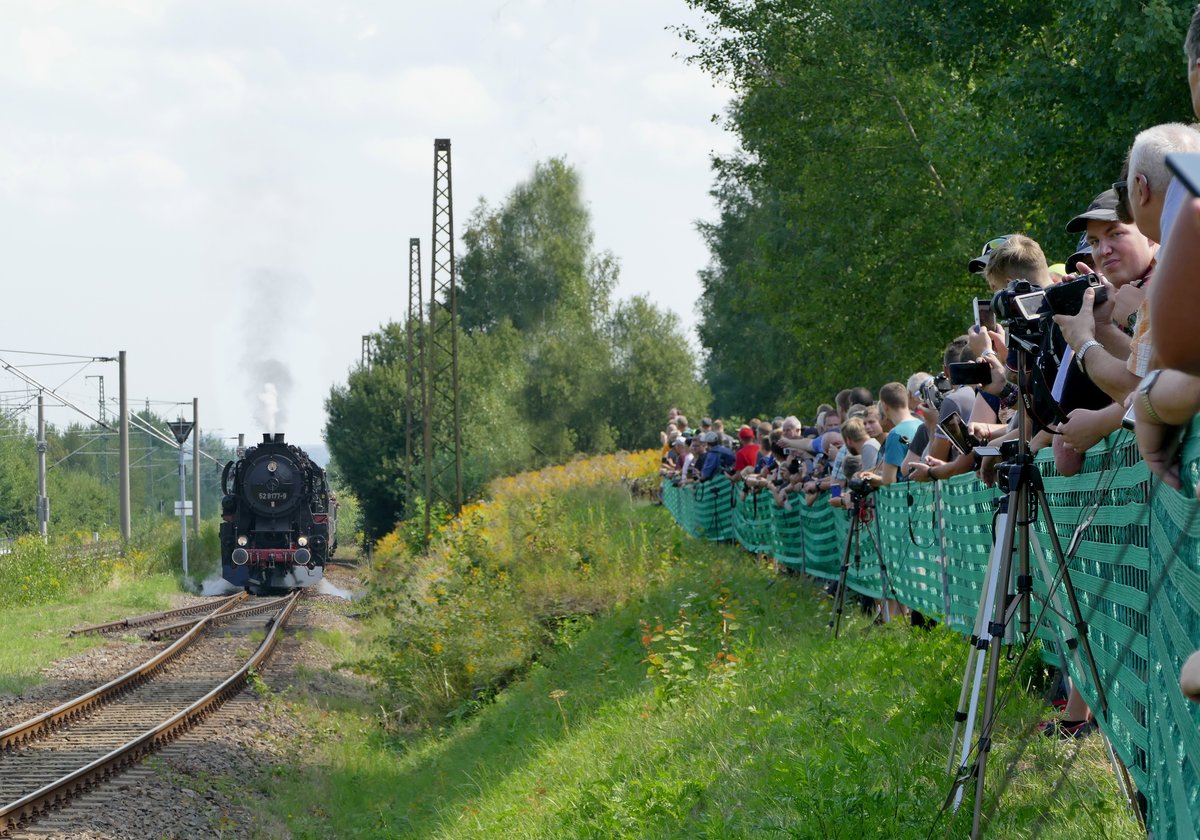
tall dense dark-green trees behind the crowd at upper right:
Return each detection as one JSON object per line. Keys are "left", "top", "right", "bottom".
{"left": 682, "top": 0, "right": 1193, "bottom": 412}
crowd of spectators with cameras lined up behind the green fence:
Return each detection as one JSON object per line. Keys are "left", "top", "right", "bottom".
{"left": 662, "top": 7, "right": 1200, "bottom": 753}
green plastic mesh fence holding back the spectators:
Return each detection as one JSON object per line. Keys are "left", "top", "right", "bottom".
{"left": 662, "top": 424, "right": 1200, "bottom": 839}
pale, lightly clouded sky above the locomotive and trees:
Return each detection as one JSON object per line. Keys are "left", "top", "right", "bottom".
{"left": 0, "top": 0, "right": 736, "bottom": 444}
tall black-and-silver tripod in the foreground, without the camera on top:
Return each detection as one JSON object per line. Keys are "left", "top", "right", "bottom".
{"left": 947, "top": 338, "right": 1120, "bottom": 840}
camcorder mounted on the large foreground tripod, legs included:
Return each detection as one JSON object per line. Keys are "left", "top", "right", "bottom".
{"left": 946, "top": 276, "right": 1134, "bottom": 839}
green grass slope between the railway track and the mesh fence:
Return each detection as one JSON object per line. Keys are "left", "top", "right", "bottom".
{"left": 265, "top": 484, "right": 1140, "bottom": 840}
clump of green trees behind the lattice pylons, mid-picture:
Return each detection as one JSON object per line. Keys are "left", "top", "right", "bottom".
{"left": 325, "top": 158, "right": 708, "bottom": 539}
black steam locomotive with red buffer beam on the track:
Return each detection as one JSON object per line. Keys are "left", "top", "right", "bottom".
{"left": 221, "top": 434, "right": 337, "bottom": 594}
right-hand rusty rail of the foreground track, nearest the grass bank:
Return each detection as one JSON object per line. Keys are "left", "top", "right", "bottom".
{"left": 0, "top": 590, "right": 304, "bottom": 834}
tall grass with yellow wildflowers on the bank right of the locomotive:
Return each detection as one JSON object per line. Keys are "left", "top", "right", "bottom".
{"left": 358, "top": 452, "right": 674, "bottom": 727}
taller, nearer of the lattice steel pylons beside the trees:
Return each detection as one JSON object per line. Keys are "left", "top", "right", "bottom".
{"left": 425, "top": 139, "right": 462, "bottom": 545}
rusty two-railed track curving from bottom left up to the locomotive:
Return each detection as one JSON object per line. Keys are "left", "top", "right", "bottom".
{"left": 0, "top": 592, "right": 301, "bottom": 835}
